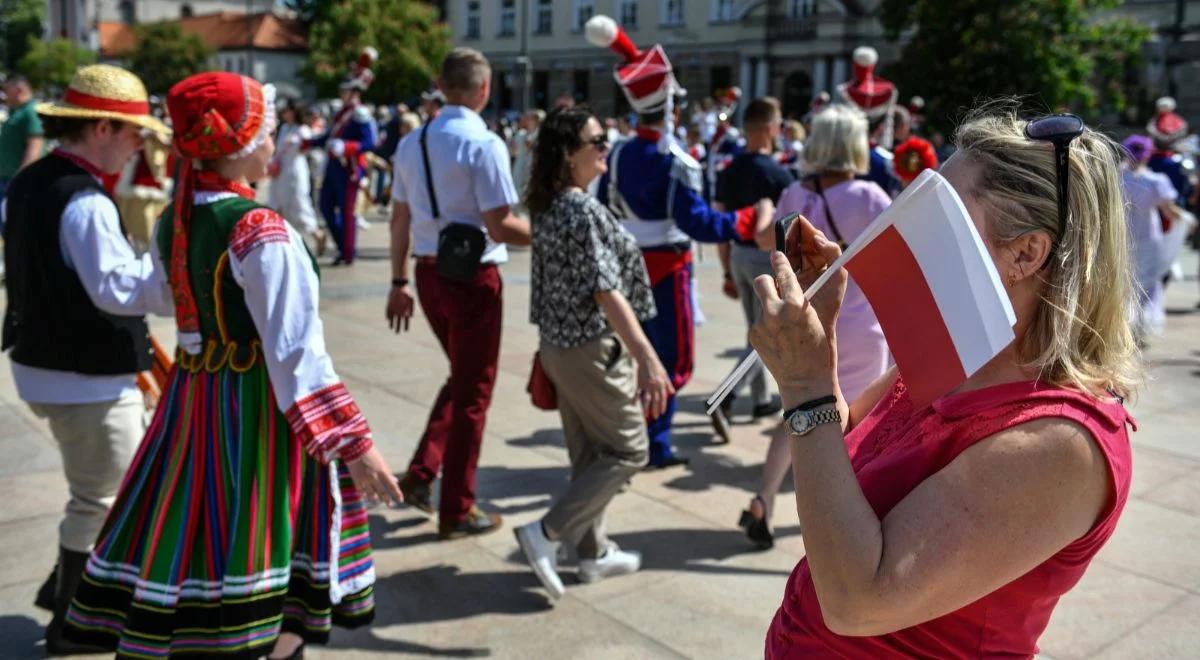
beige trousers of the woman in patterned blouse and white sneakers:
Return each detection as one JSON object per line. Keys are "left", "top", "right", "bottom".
{"left": 540, "top": 331, "right": 649, "bottom": 559}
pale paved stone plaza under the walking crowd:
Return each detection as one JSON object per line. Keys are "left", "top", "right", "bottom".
{"left": 0, "top": 217, "right": 1200, "bottom": 659}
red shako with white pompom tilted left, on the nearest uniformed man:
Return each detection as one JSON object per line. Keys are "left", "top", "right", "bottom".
{"left": 583, "top": 14, "right": 686, "bottom": 114}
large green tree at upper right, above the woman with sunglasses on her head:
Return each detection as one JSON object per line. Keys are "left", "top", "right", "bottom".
{"left": 880, "top": 0, "right": 1150, "bottom": 127}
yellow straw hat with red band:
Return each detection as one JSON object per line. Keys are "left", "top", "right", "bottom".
{"left": 36, "top": 64, "right": 170, "bottom": 136}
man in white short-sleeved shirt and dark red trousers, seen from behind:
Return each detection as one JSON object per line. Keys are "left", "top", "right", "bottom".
{"left": 386, "top": 48, "right": 529, "bottom": 539}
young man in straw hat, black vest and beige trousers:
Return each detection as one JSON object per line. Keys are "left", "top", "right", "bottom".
{"left": 2, "top": 65, "right": 173, "bottom": 654}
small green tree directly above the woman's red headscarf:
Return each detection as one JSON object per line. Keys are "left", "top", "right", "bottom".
{"left": 128, "top": 23, "right": 215, "bottom": 95}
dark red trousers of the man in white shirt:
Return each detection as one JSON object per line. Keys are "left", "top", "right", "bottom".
{"left": 408, "top": 262, "right": 504, "bottom": 522}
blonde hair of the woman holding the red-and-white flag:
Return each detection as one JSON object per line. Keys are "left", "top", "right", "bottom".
{"left": 955, "top": 104, "right": 1141, "bottom": 397}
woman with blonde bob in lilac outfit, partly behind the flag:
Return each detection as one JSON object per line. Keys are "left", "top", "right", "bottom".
{"left": 738, "top": 106, "right": 892, "bottom": 548}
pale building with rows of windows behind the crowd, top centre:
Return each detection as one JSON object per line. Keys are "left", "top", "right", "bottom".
{"left": 444, "top": 0, "right": 894, "bottom": 120}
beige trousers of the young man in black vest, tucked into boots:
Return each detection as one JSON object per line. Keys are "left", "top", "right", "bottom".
{"left": 29, "top": 394, "right": 145, "bottom": 552}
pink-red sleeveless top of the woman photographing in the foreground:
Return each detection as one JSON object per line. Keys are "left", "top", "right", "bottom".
{"left": 766, "top": 379, "right": 1136, "bottom": 658}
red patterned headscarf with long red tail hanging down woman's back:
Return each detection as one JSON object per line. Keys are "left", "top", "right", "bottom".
{"left": 167, "top": 71, "right": 275, "bottom": 353}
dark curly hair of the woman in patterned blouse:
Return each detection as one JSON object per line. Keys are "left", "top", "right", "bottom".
{"left": 524, "top": 106, "right": 599, "bottom": 220}
